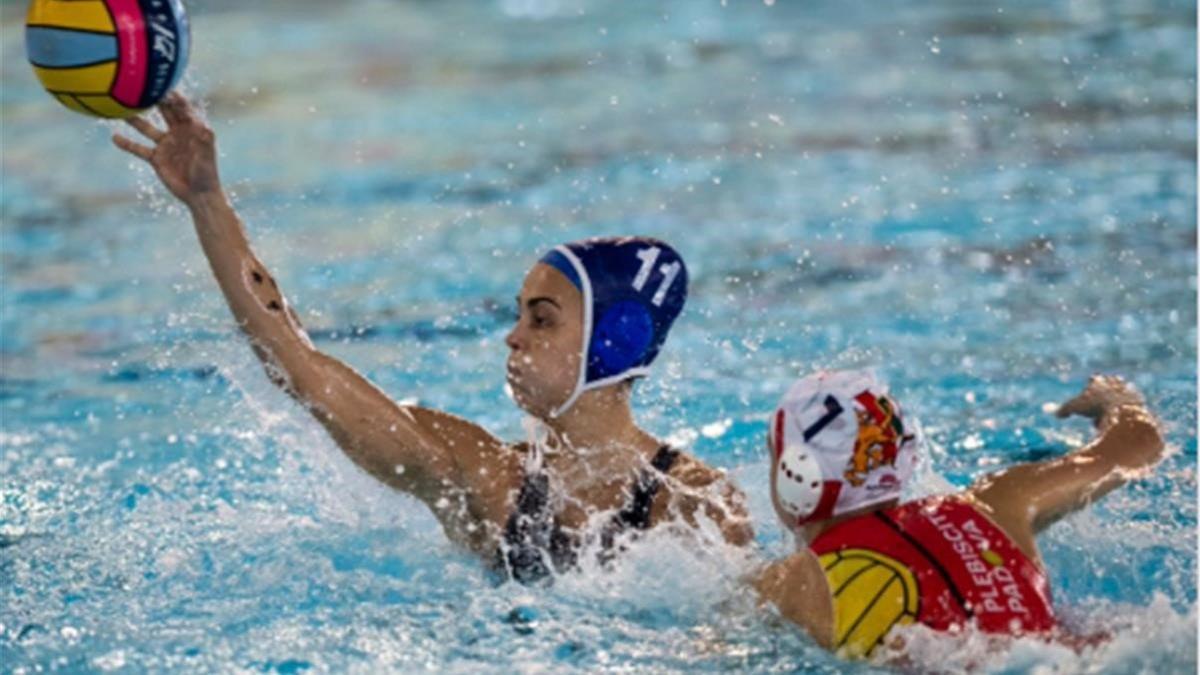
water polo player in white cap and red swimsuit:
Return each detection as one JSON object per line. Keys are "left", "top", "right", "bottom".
{"left": 755, "top": 371, "right": 1164, "bottom": 657}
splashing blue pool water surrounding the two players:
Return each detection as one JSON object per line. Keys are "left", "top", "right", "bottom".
{"left": 0, "top": 0, "right": 1196, "bottom": 674}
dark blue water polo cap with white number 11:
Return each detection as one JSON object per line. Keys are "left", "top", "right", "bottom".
{"left": 540, "top": 237, "right": 688, "bottom": 417}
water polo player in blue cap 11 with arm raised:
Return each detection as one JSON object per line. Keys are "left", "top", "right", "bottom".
{"left": 113, "top": 92, "right": 752, "bottom": 583}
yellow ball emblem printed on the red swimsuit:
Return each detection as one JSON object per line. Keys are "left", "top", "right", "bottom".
{"left": 820, "top": 549, "right": 920, "bottom": 657}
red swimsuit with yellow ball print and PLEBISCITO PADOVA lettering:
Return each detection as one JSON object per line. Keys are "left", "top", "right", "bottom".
{"left": 810, "top": 497, "right": 1055, "bottom": 655}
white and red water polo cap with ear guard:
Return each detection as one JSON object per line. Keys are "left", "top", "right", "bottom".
{"left": 768, "top": 370, "right": 920, "bottom": 527}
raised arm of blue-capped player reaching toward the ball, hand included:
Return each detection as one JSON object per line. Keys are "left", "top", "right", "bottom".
{"left": 113, "top": 94, "right": 508, "bottom": 547}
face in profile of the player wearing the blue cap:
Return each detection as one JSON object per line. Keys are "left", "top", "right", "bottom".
{"left": 505, "top": 263, "right": 583, "bottom": 418}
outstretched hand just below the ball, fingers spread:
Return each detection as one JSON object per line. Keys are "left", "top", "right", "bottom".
{"left": 113, "top": 91, "right": 221, "bottom": 204}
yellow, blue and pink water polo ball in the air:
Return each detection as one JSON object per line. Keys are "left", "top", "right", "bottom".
{"left": 25, "top": 0, "right": 191, "bottom": 118}
